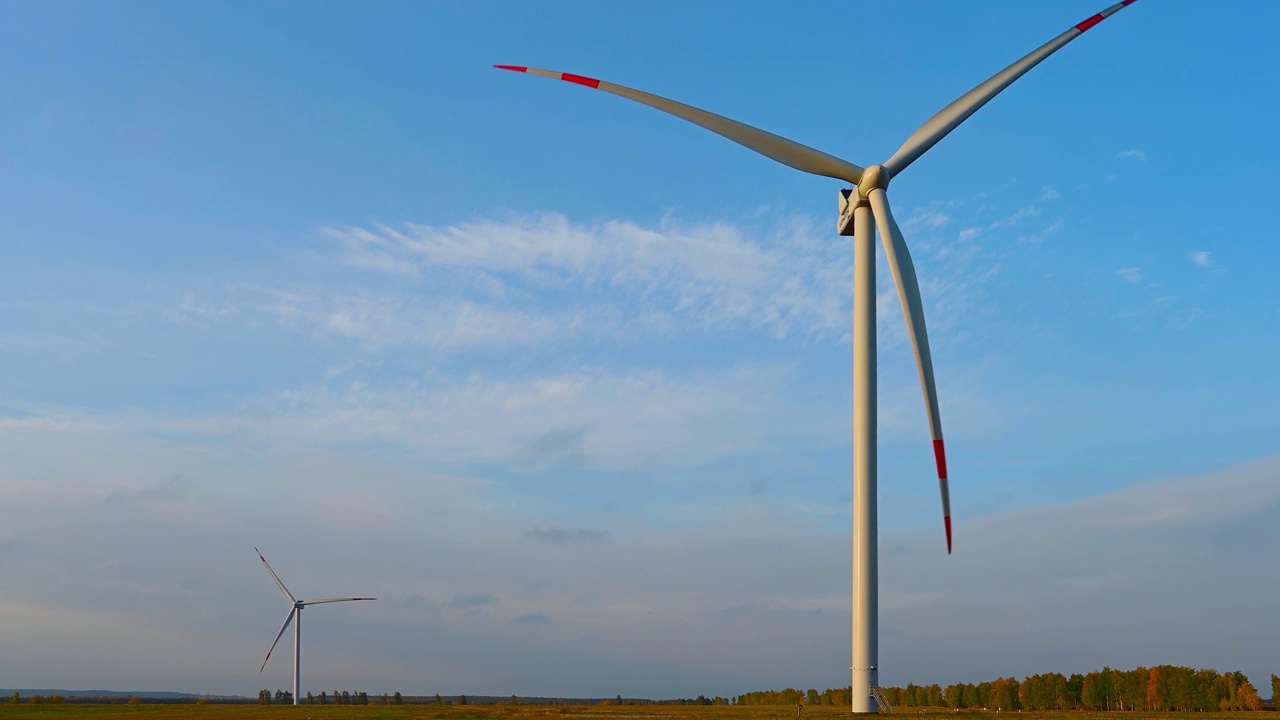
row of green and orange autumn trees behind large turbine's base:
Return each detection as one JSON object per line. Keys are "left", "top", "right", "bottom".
{"left": 733, "top": 665, "right": 1280, "bottom": 711}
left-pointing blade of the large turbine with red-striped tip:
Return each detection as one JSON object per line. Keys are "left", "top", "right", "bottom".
{"left": 494, "top": 65, "right": 863, "bottom": 184}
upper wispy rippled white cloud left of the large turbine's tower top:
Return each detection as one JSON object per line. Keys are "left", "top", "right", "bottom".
{"left": 324, "top": 214, "right": 851, "bottom": 338}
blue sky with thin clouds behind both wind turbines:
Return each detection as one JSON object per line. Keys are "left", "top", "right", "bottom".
{"left": 0, "top": 0, "right": 1280, "bottom": 697}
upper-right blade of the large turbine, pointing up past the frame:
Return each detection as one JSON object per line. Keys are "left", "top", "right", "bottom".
{"left": 884, "top": 0, "right": 1138, "bottom": 177}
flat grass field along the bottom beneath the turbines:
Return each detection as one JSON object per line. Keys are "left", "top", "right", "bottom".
{"left": 0, "top": 703, "right": 1276, "bottom": 720}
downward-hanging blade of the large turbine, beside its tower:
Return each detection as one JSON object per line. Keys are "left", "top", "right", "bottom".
{"left": 868, "top": 188, "right": 951, "bottom": 555}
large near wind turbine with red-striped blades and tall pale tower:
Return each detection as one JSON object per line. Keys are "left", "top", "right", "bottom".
{"left": 494, "top": 0, "right": 1137, "bottom": 712}
